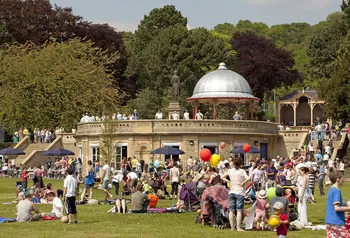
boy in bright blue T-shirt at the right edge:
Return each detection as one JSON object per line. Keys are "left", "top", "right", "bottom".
{"left": 325, "top": 168, "right": 350, "bottom": 237}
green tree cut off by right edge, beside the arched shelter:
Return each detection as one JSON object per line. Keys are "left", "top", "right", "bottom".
{"left": 319, "top": 34, "right": 350, "bottom": 121}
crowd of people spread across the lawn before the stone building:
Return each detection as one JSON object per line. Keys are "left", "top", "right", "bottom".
{"left": 9, "top": 139, "right": 350, "bottom": 237}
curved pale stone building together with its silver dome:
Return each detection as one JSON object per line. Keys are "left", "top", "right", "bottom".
{"left": 74, "top": 64, "right": 287, "bottom": 168}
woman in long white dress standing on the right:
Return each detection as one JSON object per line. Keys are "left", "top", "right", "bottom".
{"left": 297, "top": 167, "right": 309, "bottom": 226}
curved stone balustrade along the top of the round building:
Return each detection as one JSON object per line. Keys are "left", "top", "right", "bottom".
{"left": 76, "top": 120, "right": 278, "bottom": 136}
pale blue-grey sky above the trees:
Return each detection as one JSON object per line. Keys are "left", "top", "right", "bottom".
{"left": 51, "top": 0, "right": 341, "bottom": 31}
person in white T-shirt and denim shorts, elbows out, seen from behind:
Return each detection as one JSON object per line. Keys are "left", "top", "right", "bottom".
{"left": 221, "top": 158, "right": 250, "bottom": 231}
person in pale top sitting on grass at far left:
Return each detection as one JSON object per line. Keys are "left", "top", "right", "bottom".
{"left": 17, "top": 192, "right": 41, "bottom": 222}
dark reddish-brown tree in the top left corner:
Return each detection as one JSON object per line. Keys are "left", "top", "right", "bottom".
{"left": 0, "top": 0, "right": 81, "bottom": 44}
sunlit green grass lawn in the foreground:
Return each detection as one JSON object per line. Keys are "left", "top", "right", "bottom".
{"left": 0, "top": 178, "right": 350, "bottom": 238}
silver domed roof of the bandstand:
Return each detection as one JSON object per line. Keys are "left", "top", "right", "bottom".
{"left": 187, "top": 63, "right": 259, "bottom": 102}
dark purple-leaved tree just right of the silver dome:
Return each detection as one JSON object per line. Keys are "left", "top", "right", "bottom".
{"left": 231, "top": 32, "right": 301, "bottom": 99}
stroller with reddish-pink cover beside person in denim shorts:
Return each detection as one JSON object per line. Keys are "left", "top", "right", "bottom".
{"left": 195, "top": 185, "right": 230, "bottom": 229}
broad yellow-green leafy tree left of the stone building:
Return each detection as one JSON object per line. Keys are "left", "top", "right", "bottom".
{"left": 0, "top": 39, "right": 122, "bottom": 131}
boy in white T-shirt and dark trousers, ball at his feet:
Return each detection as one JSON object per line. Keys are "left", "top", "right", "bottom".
{"left": 63, "top": 168, "right": 78, "bottom": 224}
